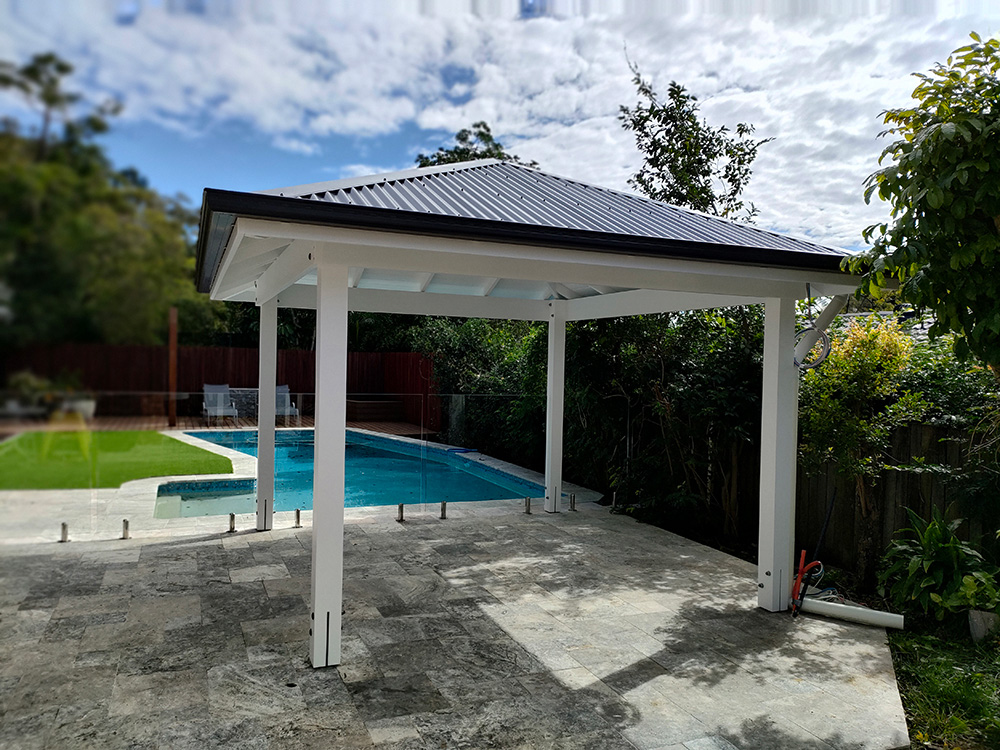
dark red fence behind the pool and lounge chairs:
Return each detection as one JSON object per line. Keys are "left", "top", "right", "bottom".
{"left": 0, "top": 344, "right": 441, "bottom": 430}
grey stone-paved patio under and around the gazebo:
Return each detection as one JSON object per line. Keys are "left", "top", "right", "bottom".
{"left": 0, "top": 485, "right": 908, "bottom": 750}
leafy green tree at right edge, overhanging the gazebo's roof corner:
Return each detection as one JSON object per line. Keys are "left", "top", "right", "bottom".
{"left": 846, "top": 33, "right": 1000, "bottom": 378}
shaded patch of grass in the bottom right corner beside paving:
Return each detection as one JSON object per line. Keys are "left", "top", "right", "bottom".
{"left": 889, "top": 625, "right": 1000, "bottom": 750}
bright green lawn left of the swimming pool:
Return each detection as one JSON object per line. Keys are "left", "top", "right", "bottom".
{"left": 0, "top": 431, "right": 233, "bottom": 490}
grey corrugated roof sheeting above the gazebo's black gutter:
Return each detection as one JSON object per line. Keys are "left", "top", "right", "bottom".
{"left": 298, "top": 162, "right": 843, "bottom": 255}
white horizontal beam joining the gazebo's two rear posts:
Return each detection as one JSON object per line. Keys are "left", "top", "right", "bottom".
{"left": 278, "top": 284, "right": 549, "bottom": 320}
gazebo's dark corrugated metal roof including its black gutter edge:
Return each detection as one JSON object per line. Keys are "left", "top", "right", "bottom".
{"left": 198, "top": 160, "right": 847, "bottom": 291}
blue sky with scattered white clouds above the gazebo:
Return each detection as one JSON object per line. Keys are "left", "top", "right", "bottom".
{"left": 0, "top": 0, "right": 1000, "bottom": 253}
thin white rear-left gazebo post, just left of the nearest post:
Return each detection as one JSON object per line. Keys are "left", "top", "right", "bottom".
{"left": 257, "top": 298, "right": 278, "bottom": 531}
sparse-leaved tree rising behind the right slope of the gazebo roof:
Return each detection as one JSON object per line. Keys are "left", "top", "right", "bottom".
{"left": 618, "top": 62, "right": 772, "bottom": 221}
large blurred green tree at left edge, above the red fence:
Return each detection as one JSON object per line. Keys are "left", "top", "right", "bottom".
{"left": 0, "top": 53, "right": 221, "bottom": 348}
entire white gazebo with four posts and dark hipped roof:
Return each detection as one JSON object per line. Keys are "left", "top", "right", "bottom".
{"left": 197, "top": 160, "right": 856, "bottom": 667}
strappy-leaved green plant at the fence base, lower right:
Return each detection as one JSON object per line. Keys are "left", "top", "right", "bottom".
{"left": 879, "top": 508, "right": 1000, "bottom": 620}
